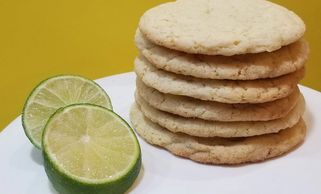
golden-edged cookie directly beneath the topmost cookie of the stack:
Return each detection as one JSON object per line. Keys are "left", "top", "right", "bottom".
{"left": 135, "top": 30, "right": 309, "bottom": 80}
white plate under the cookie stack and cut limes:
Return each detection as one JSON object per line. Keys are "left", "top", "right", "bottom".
{"left": 0, "top": 73, "right": 321, "bottom": 194}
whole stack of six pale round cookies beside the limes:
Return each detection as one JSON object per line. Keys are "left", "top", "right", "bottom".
{"left": 130, "top": 0, "right": 309, "bottom": 164}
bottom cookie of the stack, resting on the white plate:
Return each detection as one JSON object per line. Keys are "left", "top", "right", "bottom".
{"left": 130, "top": 105, "right": 306, "bottom": 164}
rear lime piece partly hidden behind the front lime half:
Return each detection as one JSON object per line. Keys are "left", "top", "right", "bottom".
{"left": 22, "top": 75, "right": 112, "bottom": 148}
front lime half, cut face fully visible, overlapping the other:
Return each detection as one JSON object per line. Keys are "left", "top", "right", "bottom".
{"left": 42, "top": 104, "right": 141, "bottom": 194}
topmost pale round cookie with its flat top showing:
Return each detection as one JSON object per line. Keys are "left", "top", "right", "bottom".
{"left": 139, "top": 0, "right": 305, "bottom": 56}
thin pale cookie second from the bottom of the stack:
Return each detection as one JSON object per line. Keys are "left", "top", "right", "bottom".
{"left": 136, "top": 96, "right": 305, "bottom": 137}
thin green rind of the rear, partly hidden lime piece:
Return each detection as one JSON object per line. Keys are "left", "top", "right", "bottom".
{"left": 21, "top": 75, "right": 113, "bottom": 149}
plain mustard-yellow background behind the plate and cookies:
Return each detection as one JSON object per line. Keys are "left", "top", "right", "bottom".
{"left": 0, "top": 0, "right": 321, "bottom": 131}
